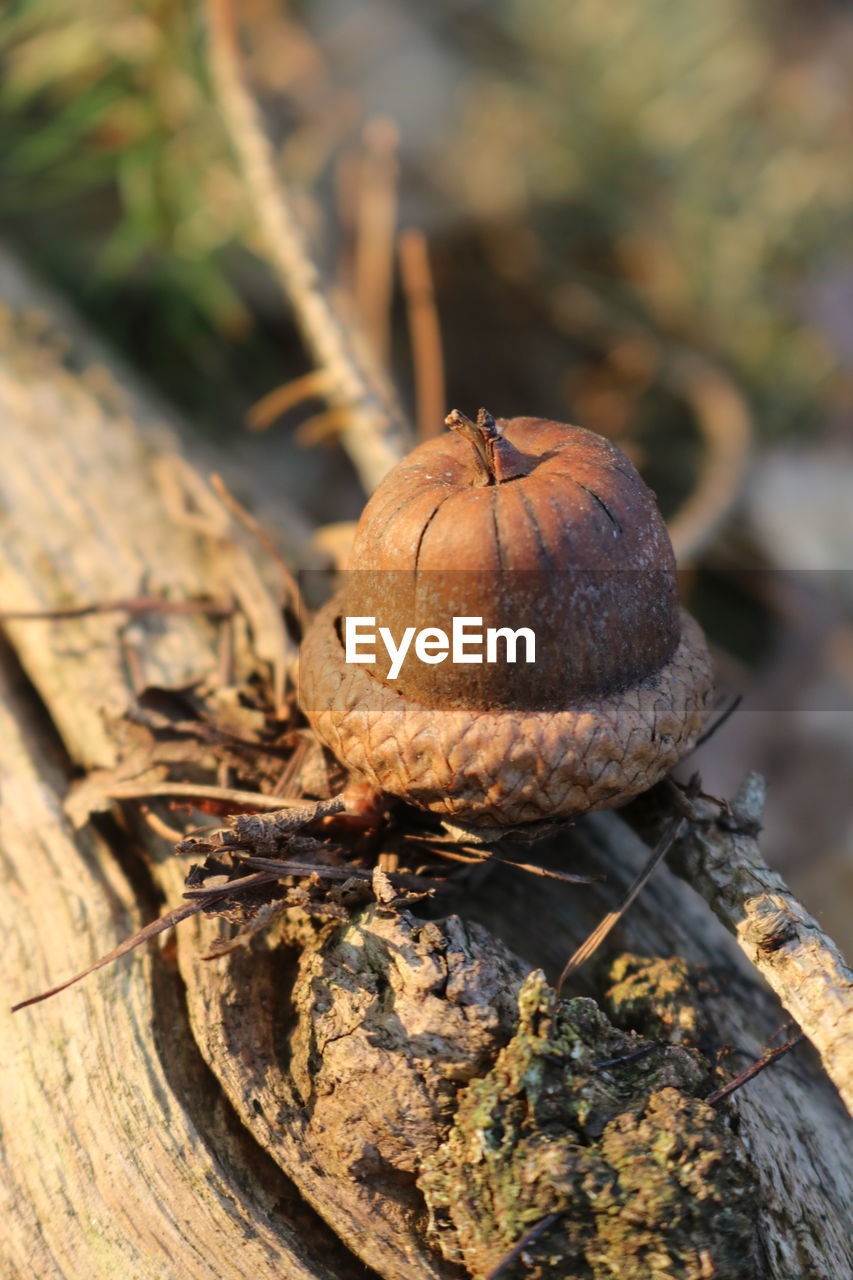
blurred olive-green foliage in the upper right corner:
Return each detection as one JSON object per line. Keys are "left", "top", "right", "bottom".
{"left": 450, "top": 0, "right": 853, "bottom": 426}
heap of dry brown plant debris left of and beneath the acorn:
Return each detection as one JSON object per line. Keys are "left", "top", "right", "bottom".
{"left": 15, "top": 600, "right": 590, "bottom": 1007}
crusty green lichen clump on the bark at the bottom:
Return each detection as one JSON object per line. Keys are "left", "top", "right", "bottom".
{"left": 419, "top": 973, "right": 753, "bottom": 1280}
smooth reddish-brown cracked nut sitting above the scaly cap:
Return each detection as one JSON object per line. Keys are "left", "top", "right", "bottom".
{"left": 343, "top": 417, "right": 680, "bottom": 710}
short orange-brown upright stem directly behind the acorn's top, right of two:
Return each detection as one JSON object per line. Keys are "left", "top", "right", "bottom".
{"left": 397, "top": 228, "right": 444, "bottom": 440}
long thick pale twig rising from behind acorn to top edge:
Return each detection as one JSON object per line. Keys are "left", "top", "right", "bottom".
{"left": 206, "top": 0, "right": 411, "bottom": 492}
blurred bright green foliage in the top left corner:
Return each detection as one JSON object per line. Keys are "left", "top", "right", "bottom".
{"left": 0, "top": 0, "right": 256, "bottom": 401}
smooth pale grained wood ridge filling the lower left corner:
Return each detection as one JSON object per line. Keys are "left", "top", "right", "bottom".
{"left": 0, "top": 653, "right": 351, "bottom": 1280}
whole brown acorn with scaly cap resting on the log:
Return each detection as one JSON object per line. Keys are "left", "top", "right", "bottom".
{"left": 300, "top": 410, "right": 713, "bottom": 831}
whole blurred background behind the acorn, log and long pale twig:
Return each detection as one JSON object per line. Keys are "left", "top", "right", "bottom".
{"left": 0, "top": 0, "right": 853, "bottom": 952}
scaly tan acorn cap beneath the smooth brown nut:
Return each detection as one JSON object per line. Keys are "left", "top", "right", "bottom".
{"left": 300, "top": 599, "right": 713, "bottom": 827}
